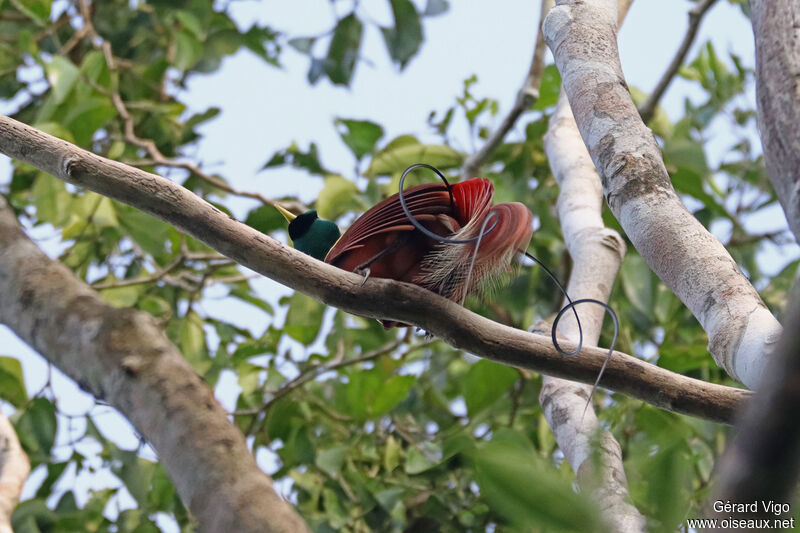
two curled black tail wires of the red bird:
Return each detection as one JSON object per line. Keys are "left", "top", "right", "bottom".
{"left": 398, "top": 163, "right": 619, "bottom": 414}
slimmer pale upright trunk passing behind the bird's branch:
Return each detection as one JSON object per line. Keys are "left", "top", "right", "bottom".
{"left": 539, "top": 2, "right": 646, "bottom": 533}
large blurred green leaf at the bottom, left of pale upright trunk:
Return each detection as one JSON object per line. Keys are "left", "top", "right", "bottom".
{"left": 472, "top": 441, "right": 606, "bottom": 532}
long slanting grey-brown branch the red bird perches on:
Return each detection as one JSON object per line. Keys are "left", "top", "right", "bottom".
{"left": 0, "top": 115, "right": 750, "bottom": 422}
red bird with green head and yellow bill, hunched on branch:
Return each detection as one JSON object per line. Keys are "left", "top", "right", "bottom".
{"left": 276, "top": 178, "right": 533, "bottom": 329}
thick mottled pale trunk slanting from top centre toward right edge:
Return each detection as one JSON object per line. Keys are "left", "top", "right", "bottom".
{"left": 543, "top": 0, "right": 781, "bottom": 388}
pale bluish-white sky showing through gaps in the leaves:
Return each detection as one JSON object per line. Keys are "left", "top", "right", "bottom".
{"left": 0, "top": 0, "right": 798, "bottom": 530}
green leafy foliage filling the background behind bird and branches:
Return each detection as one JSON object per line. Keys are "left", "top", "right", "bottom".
{"left": 0, "top": 0, "right": 797, "bottom": 533}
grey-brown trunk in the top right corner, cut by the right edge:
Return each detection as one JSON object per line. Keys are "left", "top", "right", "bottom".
{"left": 750, "top": 0, "right": 800, "bottom": 242}
